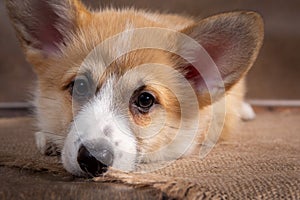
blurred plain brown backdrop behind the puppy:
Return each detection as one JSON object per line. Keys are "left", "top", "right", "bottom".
{"left": 0, "top": 0, "right": 300, "bottom": 102}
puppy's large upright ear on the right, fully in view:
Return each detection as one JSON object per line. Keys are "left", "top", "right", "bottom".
{"left": 178, "top": 12, "right": 263, "bottom": 102}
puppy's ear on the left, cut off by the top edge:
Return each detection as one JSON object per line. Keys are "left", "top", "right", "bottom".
{"left": 6, "top": 0, "right": 88, "bottom": 57}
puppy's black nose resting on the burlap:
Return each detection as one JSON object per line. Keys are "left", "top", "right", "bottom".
{"left": 77, "top": 145, "right": 113, "bottom": 177}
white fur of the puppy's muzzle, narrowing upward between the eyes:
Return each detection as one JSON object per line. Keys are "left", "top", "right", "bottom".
{"left": 62, "top": 78, "right": 137, "bottom": 175}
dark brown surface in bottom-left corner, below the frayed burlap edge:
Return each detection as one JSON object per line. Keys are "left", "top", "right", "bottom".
{"left": 0, "top": 166, "right": 165, "bottom": 200}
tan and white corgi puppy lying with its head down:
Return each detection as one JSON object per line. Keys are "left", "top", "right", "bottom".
{"left": 6, "top": 0, "right": 263, "bottom": 176}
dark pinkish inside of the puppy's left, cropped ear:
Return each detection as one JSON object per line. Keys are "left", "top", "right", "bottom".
{"left": 31, "top": 1, "right": 68, "bottom": 54}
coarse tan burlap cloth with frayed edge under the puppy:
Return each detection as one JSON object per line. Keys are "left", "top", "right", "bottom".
{"left": 0, "top": 109, "right": 300, "bottom": 199}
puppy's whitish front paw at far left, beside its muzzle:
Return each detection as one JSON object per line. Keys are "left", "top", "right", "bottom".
{"left": 35, "top": 132, "right": 61, "bottom": 156}
